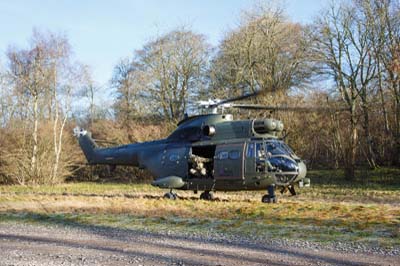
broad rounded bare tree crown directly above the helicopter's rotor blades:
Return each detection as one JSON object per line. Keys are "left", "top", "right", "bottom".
{"left": 213, "top": 2, "right": 312, "bottom": 98}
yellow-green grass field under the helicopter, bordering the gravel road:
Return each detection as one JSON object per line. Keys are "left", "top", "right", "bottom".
{"left": 0, "top": 171, "right": 400, "bottom": 247}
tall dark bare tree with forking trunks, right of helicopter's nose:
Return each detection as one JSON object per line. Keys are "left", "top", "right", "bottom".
{"left": 313, "top": 2, "right": 377, "bottom": 178}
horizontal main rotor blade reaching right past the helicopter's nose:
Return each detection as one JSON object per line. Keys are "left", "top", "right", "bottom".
{"left": 232, "top": 104, "right": 348, "bottom": 112}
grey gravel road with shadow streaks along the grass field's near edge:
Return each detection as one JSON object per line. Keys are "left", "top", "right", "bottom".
{"left": 0, "top": 222, "right": 400, "bottom": 266}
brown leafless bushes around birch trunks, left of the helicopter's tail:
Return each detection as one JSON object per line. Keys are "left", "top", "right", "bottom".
{"left": 0, "top": 124, "right": 77, "bottom": 185}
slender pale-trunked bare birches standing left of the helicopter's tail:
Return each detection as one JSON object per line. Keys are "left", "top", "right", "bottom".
{"left": 7, "top": 31, "right": 79, "bottom": 183}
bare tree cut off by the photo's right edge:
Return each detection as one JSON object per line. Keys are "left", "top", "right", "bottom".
{"left": 364, "top": 0, "right": 400, "bottom": 164}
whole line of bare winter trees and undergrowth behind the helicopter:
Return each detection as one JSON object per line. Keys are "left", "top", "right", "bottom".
{"left": 0, "top": 0, "right": 400, "bottom": 184}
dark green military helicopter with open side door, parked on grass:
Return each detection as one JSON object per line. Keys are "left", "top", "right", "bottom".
{"left": 74, "top": 93, "right": 322, "bottom": 203}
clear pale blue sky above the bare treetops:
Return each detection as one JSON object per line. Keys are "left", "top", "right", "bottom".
{"left": 0, "top": 0, "right": 329, "bottom": 86}
